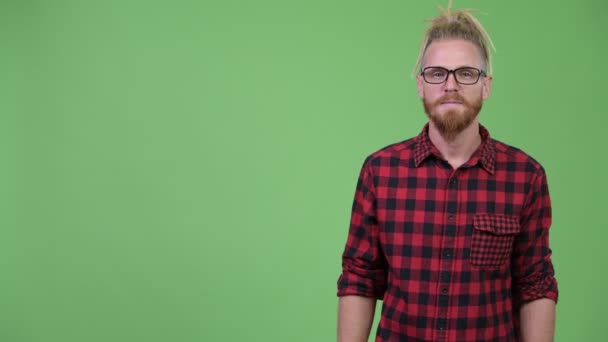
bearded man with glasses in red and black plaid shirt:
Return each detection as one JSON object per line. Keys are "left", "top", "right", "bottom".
{"left": 338, "top": 6, "right": 558, "bottom": 342}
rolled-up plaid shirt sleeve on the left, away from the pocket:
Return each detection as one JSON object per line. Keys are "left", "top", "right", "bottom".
{"left": 338, "top": 158, "right": 387, "bottom": 299}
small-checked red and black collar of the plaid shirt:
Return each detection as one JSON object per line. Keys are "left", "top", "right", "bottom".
{"left": 414, "top": 123, "right": 496, "bottom": 174}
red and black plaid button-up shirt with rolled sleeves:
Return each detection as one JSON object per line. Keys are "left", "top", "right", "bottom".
{"left": 338, "top": 125, "right": 557, "bottom": 342}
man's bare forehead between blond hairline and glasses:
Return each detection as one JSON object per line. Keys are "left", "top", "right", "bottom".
{"left": 422, "top": 39, "right": 483, "bottom": 69}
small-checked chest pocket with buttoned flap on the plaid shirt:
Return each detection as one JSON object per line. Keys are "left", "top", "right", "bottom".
{"left": 470, "top": 214, "right": 520, "bottom": 268}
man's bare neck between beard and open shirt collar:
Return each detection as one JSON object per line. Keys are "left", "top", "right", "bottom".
{"left": 429, "top": 119, "right": 481, "bottom": 169}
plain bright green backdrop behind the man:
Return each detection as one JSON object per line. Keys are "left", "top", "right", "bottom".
{"left": 0, "top": 0, "right": 608, "bottom": 342}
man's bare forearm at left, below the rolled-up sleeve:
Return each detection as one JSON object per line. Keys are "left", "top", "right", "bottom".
{"left": 338, "top": 296, "right": 376, "bottom": 342}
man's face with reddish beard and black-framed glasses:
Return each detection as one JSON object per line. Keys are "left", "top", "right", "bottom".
{"left": 416, "top": 40, "right": 492, "bottom": 141}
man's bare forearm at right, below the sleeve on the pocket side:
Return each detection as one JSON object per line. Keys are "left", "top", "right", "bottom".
{"left": 519, "top": 298, "right": 555, "bottom": 342}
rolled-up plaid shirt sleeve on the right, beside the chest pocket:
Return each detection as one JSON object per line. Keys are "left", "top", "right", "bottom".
{"left": 512, "top": 167, "right": 558, "bottom": 307}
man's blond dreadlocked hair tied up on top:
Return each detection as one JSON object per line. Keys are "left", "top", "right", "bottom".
{"left": 413, "top": 0, "right": 496, "bottom": 76}
